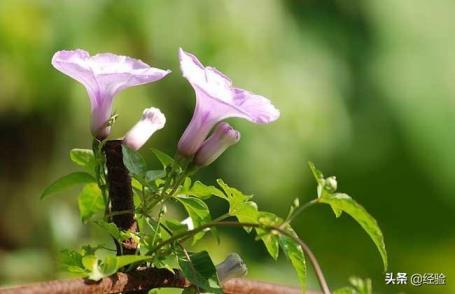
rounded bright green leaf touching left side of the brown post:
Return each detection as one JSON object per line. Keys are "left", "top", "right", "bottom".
{"left": 78, "top": 183, "right": 104, "bottom": 223}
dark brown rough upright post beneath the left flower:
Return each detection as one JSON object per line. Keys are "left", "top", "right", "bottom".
{"left": 103, "top": 140, "right": 138, "bottom": 255}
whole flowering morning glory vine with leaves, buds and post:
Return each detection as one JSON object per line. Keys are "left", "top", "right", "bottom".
{"left": 41, "top": 49, "right": 387, "bottom": 293}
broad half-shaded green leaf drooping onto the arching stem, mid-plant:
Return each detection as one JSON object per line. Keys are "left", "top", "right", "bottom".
{"left": 176, "top": 195, "right": 212, "bottom": 244}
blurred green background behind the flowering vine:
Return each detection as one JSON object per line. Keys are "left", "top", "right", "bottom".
{"left": 0, "top": 0, "right": 455, "bottom": 293}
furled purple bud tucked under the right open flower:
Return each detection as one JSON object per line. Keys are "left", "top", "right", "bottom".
{"left": 194, "top": 122, "right": 240, "bottom": 166}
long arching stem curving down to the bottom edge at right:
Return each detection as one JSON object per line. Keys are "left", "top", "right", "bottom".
{"left": 150, "top": 221, "right": 330, "bottom": 294}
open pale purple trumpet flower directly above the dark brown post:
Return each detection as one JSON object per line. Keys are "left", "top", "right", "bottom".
{"left": 52, "top": 49, "right": 170, "bottom": 140}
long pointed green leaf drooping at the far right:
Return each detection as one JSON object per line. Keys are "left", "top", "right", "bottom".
{"left": 319, "top": 193, "right": 387, "bottom": 270}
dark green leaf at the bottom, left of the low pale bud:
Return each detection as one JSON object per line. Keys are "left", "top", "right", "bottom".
{"left": 178, "top": 251, "right": 222, "bottom": 293}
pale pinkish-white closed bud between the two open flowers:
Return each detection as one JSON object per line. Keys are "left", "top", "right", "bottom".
{"left": 123, "top": 107, "right": 166, "bottom": 151}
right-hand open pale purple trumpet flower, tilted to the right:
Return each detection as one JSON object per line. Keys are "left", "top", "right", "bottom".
{"left": 177, "top": 49, "right": 280, "bottom": 157}
